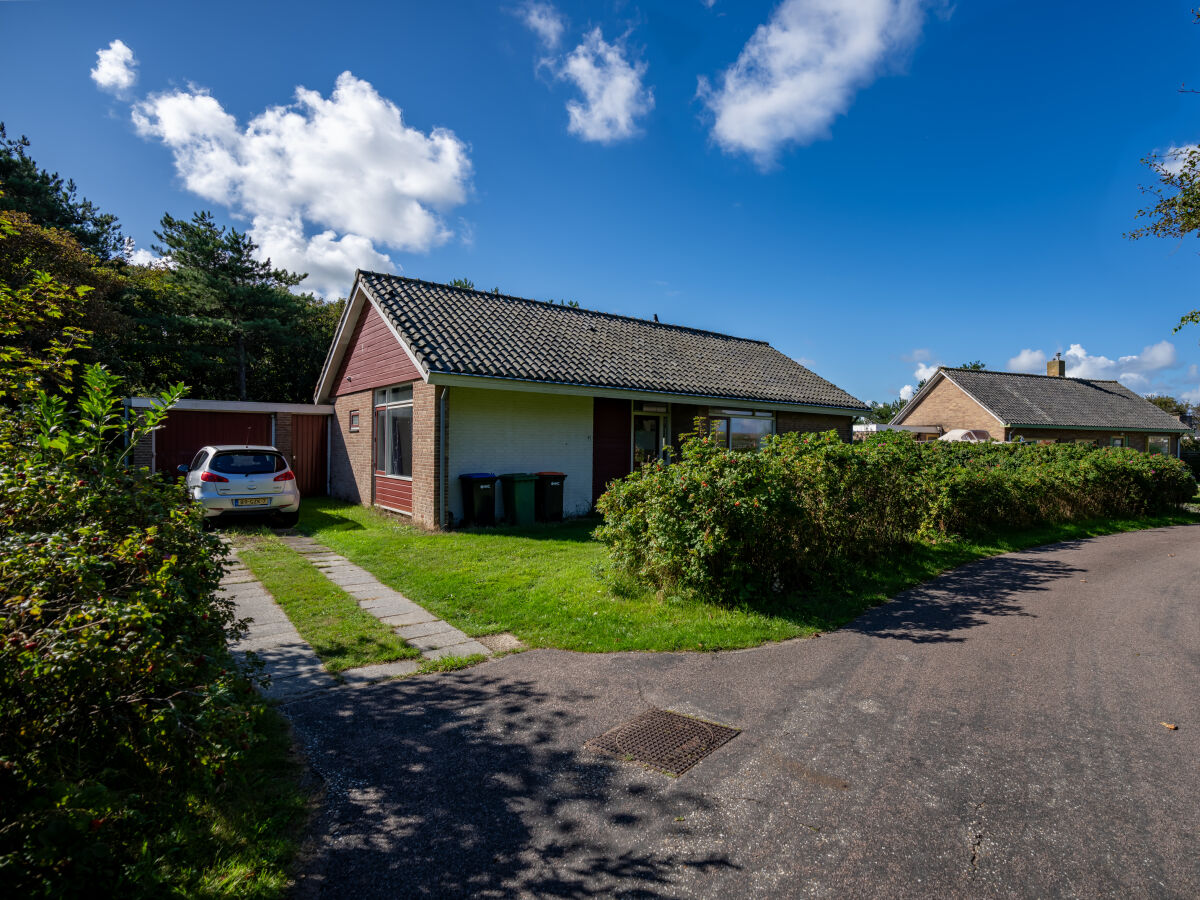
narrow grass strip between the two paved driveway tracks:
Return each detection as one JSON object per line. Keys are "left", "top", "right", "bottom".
{"left": 238, "top": 532, "right": 421, "bottom": 673}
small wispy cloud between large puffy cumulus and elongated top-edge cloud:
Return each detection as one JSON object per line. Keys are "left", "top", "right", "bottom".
{"left": 558, "top": 28, "right": 654, "bottom": 144}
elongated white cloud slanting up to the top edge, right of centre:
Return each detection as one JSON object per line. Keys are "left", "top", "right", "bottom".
{"left": 697, "top": 0, "right": 931, "bottom": 168}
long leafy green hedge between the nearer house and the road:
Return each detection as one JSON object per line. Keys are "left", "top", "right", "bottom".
{"left": 596, "top": 431, "right": 1195, "bottom": 599}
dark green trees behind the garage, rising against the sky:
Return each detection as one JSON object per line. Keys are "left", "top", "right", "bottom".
{"left": 0, "top": 126, "right": 342, "bottom": 402}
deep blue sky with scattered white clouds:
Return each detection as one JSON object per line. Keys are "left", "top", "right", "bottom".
{"left": 0, "top": 0, "right": 1200, "bottom": 402}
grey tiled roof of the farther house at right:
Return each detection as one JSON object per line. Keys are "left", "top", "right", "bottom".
{"left": 942, "top": 368, "right": 1187, "bottom": 431}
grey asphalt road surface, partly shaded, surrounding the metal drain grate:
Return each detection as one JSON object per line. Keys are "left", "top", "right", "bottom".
{"left": 286, "top": 527, "right": 1200, "bottom": 898}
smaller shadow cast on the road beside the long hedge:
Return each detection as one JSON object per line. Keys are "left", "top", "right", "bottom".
{"left": 845, "top": 544, "right": 1082, "bottom": 643}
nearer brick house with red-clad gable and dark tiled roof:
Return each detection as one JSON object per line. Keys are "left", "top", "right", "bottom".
{"left": 316, "top": 271, "right": 866, "bottom": 528}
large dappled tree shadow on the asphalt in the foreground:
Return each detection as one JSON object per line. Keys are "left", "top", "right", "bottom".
{"left": 291, "top": 671, "right": 737, "bottom": 899}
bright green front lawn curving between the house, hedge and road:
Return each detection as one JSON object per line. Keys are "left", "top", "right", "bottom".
{"left": 289, "top": 500, "right": 1200, "bottom": 652}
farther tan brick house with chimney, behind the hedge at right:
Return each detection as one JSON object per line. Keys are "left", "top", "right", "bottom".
{"left": 892, "top": 359, "right": 1187, "bottom": 456}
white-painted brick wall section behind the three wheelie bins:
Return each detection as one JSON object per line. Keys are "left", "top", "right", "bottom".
{"left": 446, "top": 386, "right": 592, "bottom": 522}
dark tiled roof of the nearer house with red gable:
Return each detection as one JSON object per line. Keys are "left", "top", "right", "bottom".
{"left": 360, "top": 272, "right": 865, "bottom": 409}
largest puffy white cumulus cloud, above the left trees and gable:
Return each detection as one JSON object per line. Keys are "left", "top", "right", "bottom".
{"left": 133, "top": 72, "right": 472, "bottom": 295}
